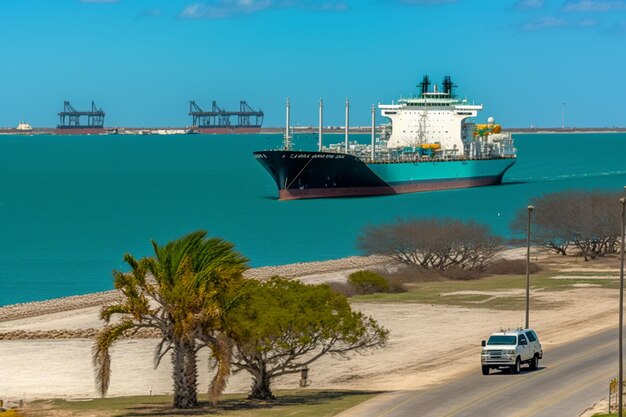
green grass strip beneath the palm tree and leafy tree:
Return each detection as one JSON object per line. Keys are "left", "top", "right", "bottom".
{"left": 25, "top": 390, "right": 380, "bottom": 417}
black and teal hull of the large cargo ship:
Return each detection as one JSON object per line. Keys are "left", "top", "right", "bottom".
{"left": 254, "top": 150, "right": 515, "bottom": 200}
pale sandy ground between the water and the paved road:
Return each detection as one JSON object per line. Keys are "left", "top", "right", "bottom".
{"left": 0, "top": 249, "right": 618, "bottom": 412}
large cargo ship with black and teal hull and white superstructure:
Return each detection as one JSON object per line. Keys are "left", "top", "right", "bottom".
{"left": 254, "top": 76, "right": 517, "bottom": 200}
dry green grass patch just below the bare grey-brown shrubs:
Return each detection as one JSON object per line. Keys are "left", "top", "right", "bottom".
{"left": 351, "top": 271, "right": 619, "bottom": 310}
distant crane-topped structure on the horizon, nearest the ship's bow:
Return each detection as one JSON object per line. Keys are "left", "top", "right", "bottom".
{"left": 189, "top": 100, "right": 263, "bottom": 134}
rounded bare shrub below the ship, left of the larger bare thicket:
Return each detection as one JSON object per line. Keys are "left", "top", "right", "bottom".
{"left": 357, "top": 218, "right": 502, "bottom": 270}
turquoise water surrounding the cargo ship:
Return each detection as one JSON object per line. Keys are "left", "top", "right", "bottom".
{"left": 0, "top": 134, "right": 626, "bottom": 305}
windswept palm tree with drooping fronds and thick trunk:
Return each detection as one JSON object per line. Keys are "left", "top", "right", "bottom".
{"left": 93, "top": 231, "right": 247, "bottom": 408}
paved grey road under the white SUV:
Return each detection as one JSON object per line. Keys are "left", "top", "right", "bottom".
{"left": 340, "top": 329, "right": 618, "bottom": 417}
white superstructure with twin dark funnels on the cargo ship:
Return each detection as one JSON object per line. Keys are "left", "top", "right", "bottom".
{"left": 378, "top": 76, "right": 515, "bottom": 158}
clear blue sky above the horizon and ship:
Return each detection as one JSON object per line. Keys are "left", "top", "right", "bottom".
{"left": 0, "top": 0, "right": 626, "bottom": 127}
